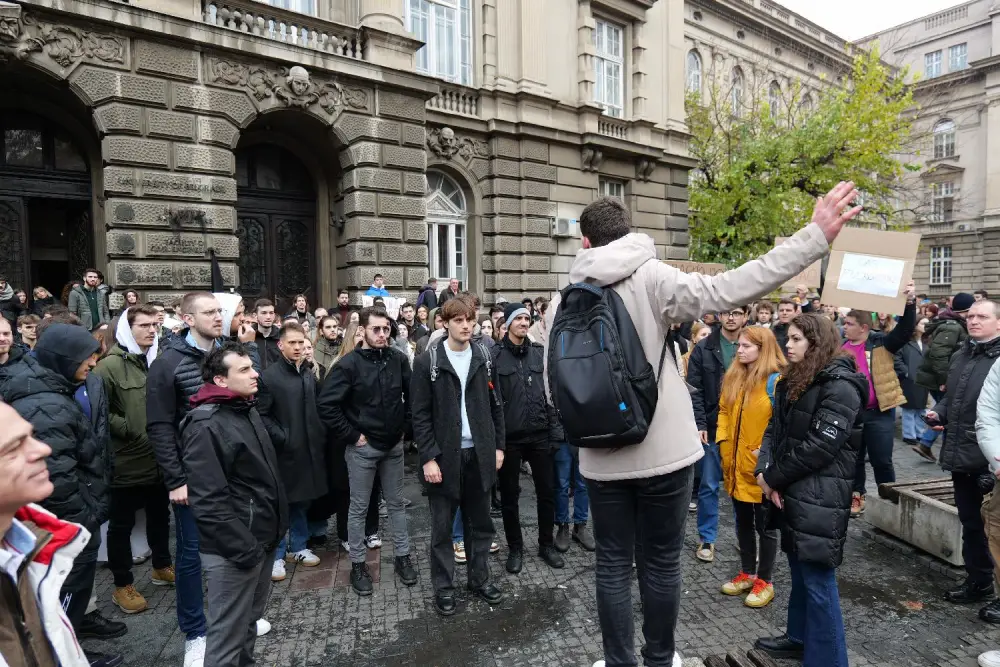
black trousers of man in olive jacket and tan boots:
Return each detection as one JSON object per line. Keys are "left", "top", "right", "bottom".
{"left": 108, "top": 484, "right": 171, "bottom": 587}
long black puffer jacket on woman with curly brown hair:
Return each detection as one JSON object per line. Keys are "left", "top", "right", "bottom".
{"left": 757, "top": 357, "right": 868, "bottom": 567}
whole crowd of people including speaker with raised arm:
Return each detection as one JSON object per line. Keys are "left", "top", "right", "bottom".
{"left": 0, "top": 183, "right": 1000, "bottom": 667}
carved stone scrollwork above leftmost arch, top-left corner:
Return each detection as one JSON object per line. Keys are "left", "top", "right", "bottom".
{"left": 0, "top": 2, "right": 125, "bottom": 67}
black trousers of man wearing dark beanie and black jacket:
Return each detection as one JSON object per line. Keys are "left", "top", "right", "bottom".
{"left": 498, "top": 443, "right": 556, "bottom": 551}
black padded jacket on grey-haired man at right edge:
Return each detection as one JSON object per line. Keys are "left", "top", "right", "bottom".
{"left": 934, "top": 338, "right": 1000, "bottom": 473}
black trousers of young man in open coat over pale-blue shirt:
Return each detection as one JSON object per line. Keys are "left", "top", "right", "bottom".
{"left": 427, "top": 449, "right": 494, "bottom": 595}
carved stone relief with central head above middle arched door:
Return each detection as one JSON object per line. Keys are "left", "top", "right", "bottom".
{"left": 209, "top": 60, "right": 369, "bottom": 116}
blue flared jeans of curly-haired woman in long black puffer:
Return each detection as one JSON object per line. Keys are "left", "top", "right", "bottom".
{"left": 788, "top": 553, "right": 848, "bottom": 667}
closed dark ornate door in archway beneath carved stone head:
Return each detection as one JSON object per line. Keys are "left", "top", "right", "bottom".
{"left": 236, "top": 144, "right": 318, "bottom": 315}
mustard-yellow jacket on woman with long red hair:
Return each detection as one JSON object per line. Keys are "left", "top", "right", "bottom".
{"left": 716, "top": 379, "right": 771, "bottom": 503}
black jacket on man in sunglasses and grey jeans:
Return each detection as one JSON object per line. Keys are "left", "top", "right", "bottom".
{"left": 316, "top": 347, "right": 411, "bottom": 451}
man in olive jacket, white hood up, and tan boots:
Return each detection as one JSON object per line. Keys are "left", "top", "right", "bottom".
{"left": 94, "top": 306, "right": 174, "bottom": 614}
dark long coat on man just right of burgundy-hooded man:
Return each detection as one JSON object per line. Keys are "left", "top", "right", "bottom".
{"left": 257, "top": 358, "right": 327, "bottom": 503}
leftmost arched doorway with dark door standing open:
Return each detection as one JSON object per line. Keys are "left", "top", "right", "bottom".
{"left": 0, "top": 110, "right": 94, "bottom": 294}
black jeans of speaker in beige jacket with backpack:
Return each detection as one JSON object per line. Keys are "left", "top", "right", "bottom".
{"left": 587, "top": 466, "right": 694, "bottom": 667}
